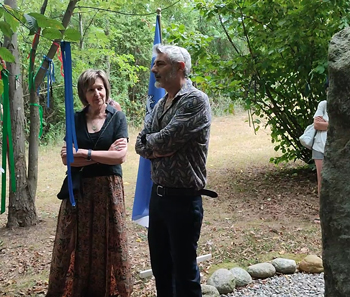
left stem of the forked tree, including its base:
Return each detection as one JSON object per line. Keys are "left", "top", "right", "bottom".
{"left": 4, "top": 0, "right": 37, "bottom": 227}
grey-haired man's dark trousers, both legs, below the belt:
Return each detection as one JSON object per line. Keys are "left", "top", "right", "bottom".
{"left": 148, "top": 185, "right": 203, "bottom": 297}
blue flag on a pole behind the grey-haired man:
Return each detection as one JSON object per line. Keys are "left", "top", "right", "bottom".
{"left": 132, "top": 15, "right": 165, "bottom": 227}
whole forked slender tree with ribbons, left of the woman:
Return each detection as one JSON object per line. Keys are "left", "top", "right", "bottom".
{"left": 5, "top": 0, "right": 78, "bottom": 227}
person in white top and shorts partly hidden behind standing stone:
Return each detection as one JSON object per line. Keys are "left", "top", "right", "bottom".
{"left": 312, "top": 83, "right": 329, "bottom": 197}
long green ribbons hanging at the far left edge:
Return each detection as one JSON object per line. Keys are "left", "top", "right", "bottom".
{"left": 0, "top": 69, "right": 16, "bottom": 214}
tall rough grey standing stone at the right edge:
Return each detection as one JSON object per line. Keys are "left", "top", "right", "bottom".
{"left": 320, "top": 28, "right": 350, "bottom": 297}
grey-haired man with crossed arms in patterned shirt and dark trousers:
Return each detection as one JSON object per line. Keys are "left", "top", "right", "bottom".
{"left": 135, "top": 45, "right": 216, "bottom": 297}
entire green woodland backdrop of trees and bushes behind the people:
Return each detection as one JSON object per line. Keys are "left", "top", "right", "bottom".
{"left": 0, "top": 0, "right": 350, "bottom": 163}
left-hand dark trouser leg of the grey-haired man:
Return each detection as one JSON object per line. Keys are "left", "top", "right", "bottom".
{"left": 148, "top": 189, "right": 174, "bottom": 297}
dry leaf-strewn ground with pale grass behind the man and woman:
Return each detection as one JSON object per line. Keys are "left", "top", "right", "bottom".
{"left": 0, "top": 113, "right": 321, "bottom": 297}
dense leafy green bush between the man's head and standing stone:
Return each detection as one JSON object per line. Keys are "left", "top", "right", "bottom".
{"left": 168, "top": 0, "right": 350, "bottom": 163}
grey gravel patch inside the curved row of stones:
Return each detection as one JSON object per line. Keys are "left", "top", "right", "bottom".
{"left": 221, "top": 273, "right": 324, "bottom": 297}
